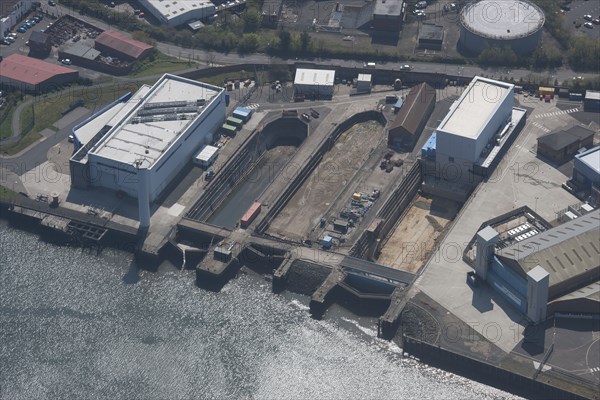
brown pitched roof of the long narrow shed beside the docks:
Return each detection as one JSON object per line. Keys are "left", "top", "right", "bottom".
{"left": 390, "top": 82, "right": 435, "bottom": 136}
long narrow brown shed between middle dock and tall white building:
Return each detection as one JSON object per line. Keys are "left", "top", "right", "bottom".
{"left": 388, "top": 82, "right": 436, "bottom": 149}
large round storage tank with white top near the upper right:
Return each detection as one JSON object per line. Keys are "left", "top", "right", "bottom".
{"left": 458, "top": 0, "right": 546, "bottom": 55}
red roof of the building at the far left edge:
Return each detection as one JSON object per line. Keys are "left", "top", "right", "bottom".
{"left": 0, "top": 54, "right": 77, "bottom": 85}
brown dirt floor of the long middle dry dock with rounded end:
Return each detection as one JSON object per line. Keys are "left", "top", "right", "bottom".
{"left": 269, "top": 121, "right": 385, "bottom": 240}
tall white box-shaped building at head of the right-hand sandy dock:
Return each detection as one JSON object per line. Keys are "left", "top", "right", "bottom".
{"left": 436, "top": 76, "right": 514, "bottom": 178}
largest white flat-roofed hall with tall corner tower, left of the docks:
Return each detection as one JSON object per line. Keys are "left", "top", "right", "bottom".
{"left": 69, "top": 74, "right": 226, "bottom": 226}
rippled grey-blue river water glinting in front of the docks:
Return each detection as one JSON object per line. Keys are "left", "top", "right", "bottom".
{"left": 0, "top": 222, "right": 511, "bottom": 400}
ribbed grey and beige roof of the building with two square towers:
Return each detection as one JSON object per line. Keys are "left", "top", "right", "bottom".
{"left": 497, "top": 209, "right": 600, "bottom": 286}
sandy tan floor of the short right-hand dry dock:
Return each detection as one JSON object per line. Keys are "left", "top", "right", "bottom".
{"left": 377, "top": 196, "right": 460, "bottom": 273}
